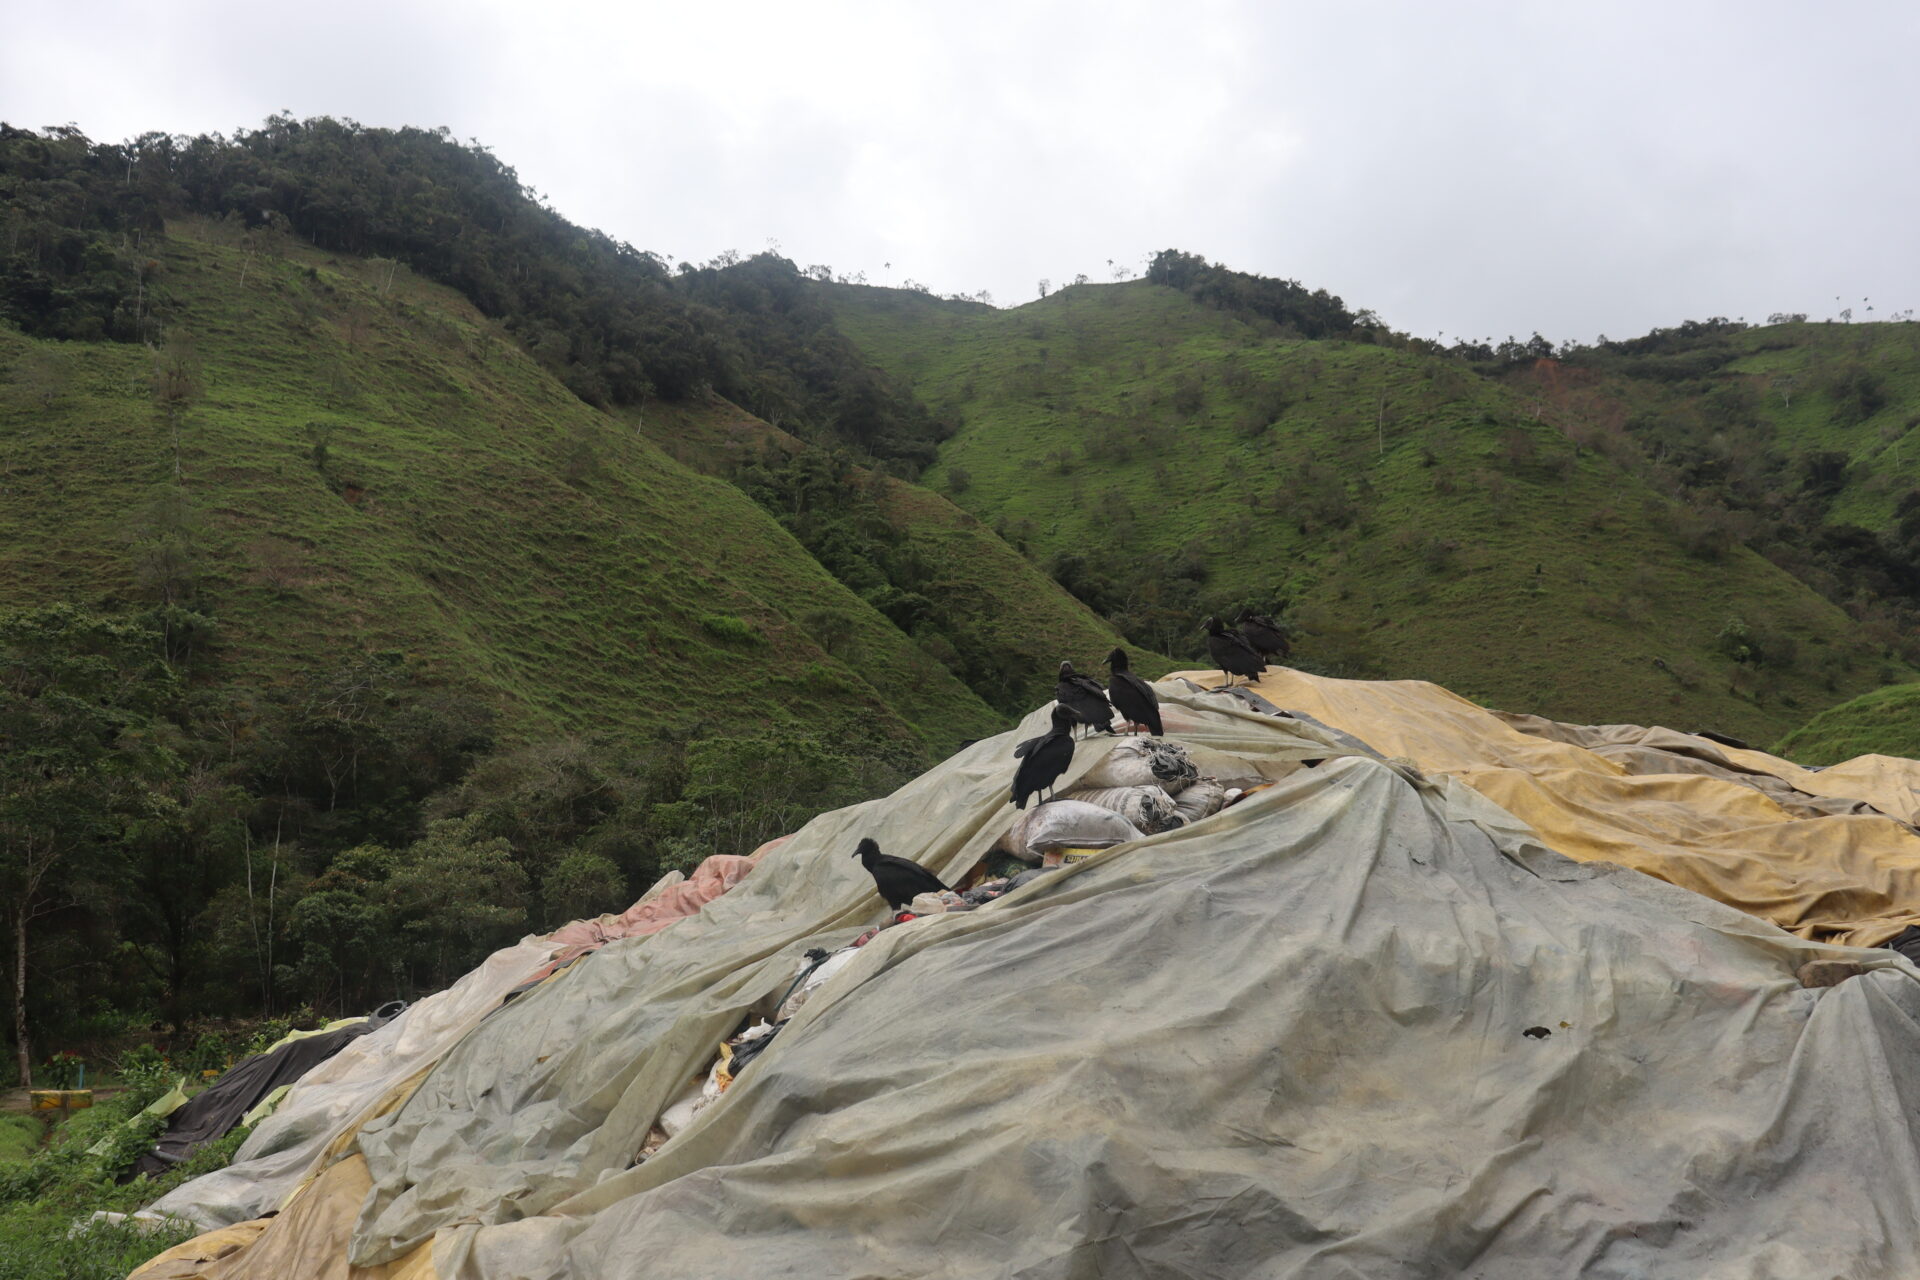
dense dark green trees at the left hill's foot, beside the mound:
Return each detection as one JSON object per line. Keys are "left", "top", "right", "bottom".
{"left": 0, "top": 604, "right": 883, "bottom": 1082}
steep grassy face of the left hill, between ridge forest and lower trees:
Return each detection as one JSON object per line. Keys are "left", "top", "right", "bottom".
{"left": 0, "top": 225, "right": 1000, "bottom": 758}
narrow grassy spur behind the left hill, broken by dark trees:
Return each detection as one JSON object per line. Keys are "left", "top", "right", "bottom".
{"left": 643, "top": 399, "right": 1171, "bottom": 702}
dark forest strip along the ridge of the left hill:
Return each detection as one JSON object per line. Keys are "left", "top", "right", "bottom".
{"left": 0, "top": 115, "right": 941, "bottom": 470}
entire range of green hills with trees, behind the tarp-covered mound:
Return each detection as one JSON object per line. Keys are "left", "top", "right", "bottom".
{"left": 0, "top": 117, "right": 1920, "bottom": 1105}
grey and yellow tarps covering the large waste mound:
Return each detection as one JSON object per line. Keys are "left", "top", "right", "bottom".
{"left": 134, "top": 672, "right": 1920, "bottom": 1280}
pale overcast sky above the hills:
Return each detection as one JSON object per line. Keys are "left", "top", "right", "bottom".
{"left": 0, "top": 0, "right": 1920, "bottom": 340}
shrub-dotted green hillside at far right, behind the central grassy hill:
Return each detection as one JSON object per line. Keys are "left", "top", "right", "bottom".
{"left": 1482, "top": 317, "right": 1920, "bottom": 662}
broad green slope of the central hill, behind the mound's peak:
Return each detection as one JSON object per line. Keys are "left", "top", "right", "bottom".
{"left": 831, "top": 282, "right": 1899, "bottom": 739}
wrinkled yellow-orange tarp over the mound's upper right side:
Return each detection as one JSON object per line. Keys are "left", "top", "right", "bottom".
{"left": 1169, "top": 668, "right": 1920, "bottom": 946}
